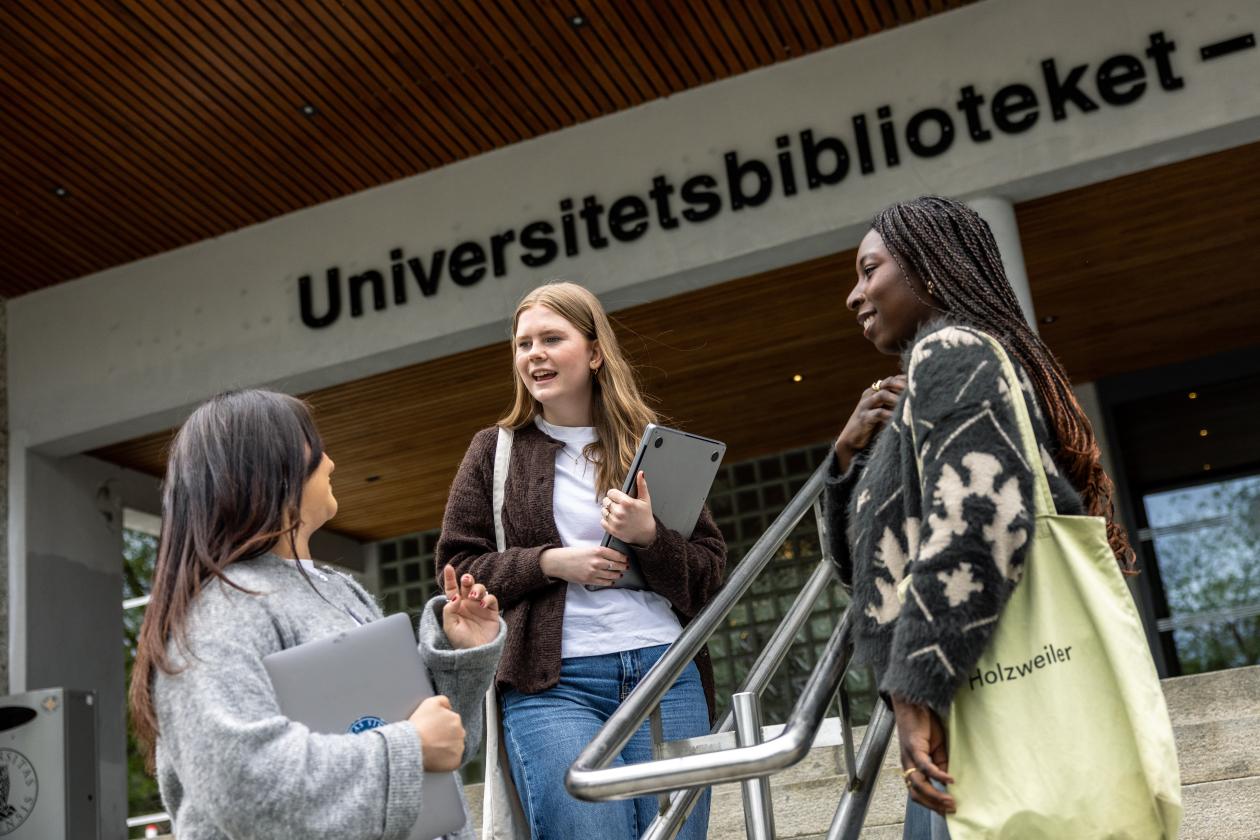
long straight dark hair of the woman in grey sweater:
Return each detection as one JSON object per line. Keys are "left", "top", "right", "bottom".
{"left": 130, "top": 390, "right": 324, "bottom": 768}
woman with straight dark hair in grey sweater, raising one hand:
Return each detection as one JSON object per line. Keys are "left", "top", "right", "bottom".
{"left": 131, "top": 390, "right": 505, "bottom": 840}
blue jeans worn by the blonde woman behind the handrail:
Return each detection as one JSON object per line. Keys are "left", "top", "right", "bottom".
{"left": 503, "top": 645, "right": 709, "bottom": 840}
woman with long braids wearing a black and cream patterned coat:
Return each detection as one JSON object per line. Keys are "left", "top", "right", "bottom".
{"left": 824, "top": 196, "right": 1133, "bottom": 840}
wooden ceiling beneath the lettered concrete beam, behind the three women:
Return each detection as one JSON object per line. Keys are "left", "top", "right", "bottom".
{"left": 95, "top": 144, "right": 1260, "bottom": 539}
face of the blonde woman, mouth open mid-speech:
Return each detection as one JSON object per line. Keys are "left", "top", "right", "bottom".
{"left": 515, "top": 304, "right": 604, "bottom": 426}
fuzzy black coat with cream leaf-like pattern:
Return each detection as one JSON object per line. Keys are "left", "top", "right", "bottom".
{"left": 824, "top": 321, "right": 1082, "bottom": 717}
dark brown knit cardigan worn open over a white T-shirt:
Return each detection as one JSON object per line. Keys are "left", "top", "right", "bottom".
{"left": 436, "top": 423, "right": 726, "bottom": 719}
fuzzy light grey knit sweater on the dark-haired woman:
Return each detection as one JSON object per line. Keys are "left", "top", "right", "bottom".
{"left": 154, "top": 555, "right": 505, "bottom": 840}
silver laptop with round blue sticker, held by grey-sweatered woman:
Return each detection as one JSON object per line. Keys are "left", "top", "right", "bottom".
{"left": 262, "top": 613, "right": 465, "bottom": 840}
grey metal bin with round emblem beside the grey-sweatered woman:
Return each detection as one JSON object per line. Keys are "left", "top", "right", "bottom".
{"left": 0, "top": 689, "right": 100, "bottom": 840}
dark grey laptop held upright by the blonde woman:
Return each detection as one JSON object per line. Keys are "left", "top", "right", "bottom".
{"left": 586, "top": 423, "right": 726, "bottom": 589}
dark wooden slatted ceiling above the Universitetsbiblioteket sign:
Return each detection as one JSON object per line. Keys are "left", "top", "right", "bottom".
{"left": 0, "top": 0, "right": 971, "bottom": 297}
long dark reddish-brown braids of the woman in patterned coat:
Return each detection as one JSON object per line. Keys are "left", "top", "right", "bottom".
{"left": 871, "top": 195, "right": 1137, "bottom": 574}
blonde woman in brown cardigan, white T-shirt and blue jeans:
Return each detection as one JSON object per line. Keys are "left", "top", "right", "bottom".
{"left": 436, "top": 282, "right": 726, "bottom": 840}
